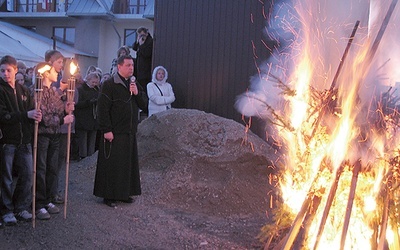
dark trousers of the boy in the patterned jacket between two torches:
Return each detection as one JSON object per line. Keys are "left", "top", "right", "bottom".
{"left": 36, "top": 134, "right": 60, "bottom": 209}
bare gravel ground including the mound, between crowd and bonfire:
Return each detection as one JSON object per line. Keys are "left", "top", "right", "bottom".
{"left": 0, "top": 110, "right": 276, "bottom": 249}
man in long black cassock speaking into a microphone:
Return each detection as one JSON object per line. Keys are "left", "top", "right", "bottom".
{"left": 93, "top": 55, "right": 148, "bottom": 207}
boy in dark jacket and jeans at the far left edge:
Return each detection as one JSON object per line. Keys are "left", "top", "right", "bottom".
{"left": 0, "top": 56, "right": 42, "bottom": 225}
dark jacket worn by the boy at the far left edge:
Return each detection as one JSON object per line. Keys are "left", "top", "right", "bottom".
{"left": 0, "top": 78, "right": 34, "bottom": 144}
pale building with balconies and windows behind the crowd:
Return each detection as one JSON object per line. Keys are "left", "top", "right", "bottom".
{"left": 0, "top": 0, "right": 154, "bottom": 75}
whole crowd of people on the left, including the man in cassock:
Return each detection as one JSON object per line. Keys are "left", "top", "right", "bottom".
{"left": 0, "top": 28, "right": 175, "bottom": 225}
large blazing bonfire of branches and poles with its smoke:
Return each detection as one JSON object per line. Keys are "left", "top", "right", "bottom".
{"left": 236, "top": 0, "right": 400, "bottom": 250}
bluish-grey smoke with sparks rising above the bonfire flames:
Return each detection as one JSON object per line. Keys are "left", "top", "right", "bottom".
{"left": 235, "top": 0, "right": 400, "bottom": 123}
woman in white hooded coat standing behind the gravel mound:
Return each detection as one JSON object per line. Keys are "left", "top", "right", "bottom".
{"left": 147, "top": 66, "right": 175, "bottom": 117}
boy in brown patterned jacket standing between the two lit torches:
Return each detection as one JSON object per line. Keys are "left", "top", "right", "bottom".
{"left": 36, "top": 62, "right": 74, "bottom": 220}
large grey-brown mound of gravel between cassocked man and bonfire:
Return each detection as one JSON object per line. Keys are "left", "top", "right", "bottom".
{"left": 138, "top": 109, "right": 276, "bottom": 216}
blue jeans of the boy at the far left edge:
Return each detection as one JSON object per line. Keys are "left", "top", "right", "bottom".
{"left": 0, "top": 144, "right": 33, "bottom": 215}
